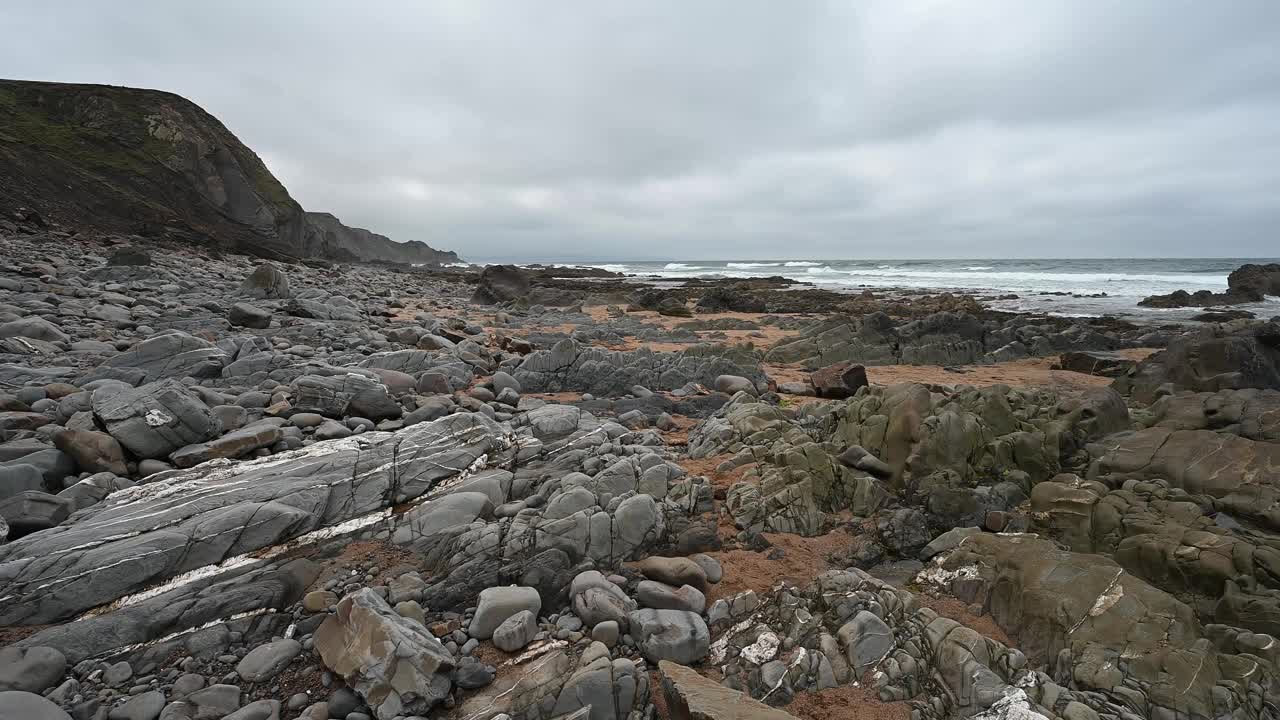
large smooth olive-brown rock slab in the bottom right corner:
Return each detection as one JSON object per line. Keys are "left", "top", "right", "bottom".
{"left": 922, "top": 534, "right": 1276, "bottom": 717}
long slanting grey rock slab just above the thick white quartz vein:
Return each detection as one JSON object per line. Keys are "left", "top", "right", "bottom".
{"left": 0, "top": 413, "right": 511, "bottom": 625}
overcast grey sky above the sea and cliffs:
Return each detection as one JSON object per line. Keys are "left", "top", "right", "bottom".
{"left": 0, "top": 0, "right": 1280, "bottom": 260}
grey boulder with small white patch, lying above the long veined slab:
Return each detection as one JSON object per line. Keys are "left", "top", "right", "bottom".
{"left": 93, "top": 380, "right": 223, "bottom": 459}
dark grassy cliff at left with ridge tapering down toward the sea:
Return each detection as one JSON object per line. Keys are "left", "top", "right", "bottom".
{"left": 0, "top": 79, "right": 457, "bottom": 263}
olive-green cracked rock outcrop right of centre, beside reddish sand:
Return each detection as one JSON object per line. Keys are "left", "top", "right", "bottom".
{"left": 689, "top": 384, "right": 1129, "bottom": 538}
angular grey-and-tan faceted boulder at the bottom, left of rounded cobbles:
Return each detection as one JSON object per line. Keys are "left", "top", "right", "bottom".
{"left": 315, "top": 588, "right": 454, "bottom": 720}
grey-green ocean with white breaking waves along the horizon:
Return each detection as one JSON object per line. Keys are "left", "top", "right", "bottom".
{"left": 568, "top": 258, "right": 1280, "bottom": 322}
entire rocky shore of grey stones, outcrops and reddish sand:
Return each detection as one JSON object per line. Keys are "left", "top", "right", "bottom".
{"left": 0, "top": 214, "right": 1280, "bottom": 720}
